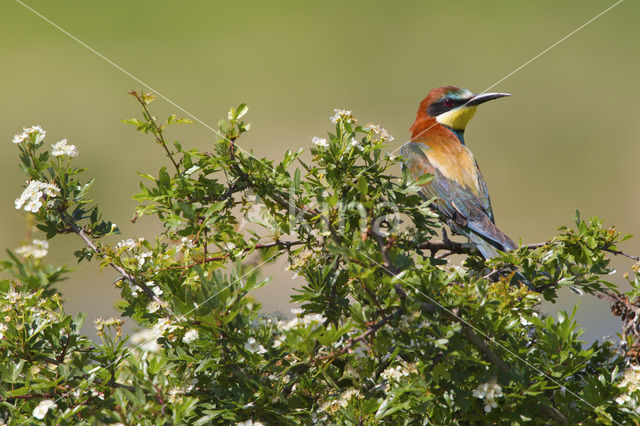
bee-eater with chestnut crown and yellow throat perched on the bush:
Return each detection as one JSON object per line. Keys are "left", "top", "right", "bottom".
{"left": 401, "top": 86, "right": 517, "bottom": 259}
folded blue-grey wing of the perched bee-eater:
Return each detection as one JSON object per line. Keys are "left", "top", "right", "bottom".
{"left": 400, "top": 142, "right": 516, "bottom": 257}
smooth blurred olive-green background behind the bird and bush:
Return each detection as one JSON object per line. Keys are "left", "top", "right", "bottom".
{"left": 0, "top": 0, "right": 640, "bottom": 340}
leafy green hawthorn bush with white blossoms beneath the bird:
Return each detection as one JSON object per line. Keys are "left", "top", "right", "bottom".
{"left": 0, "top": 92, "right": 640, "bottom": 425}
